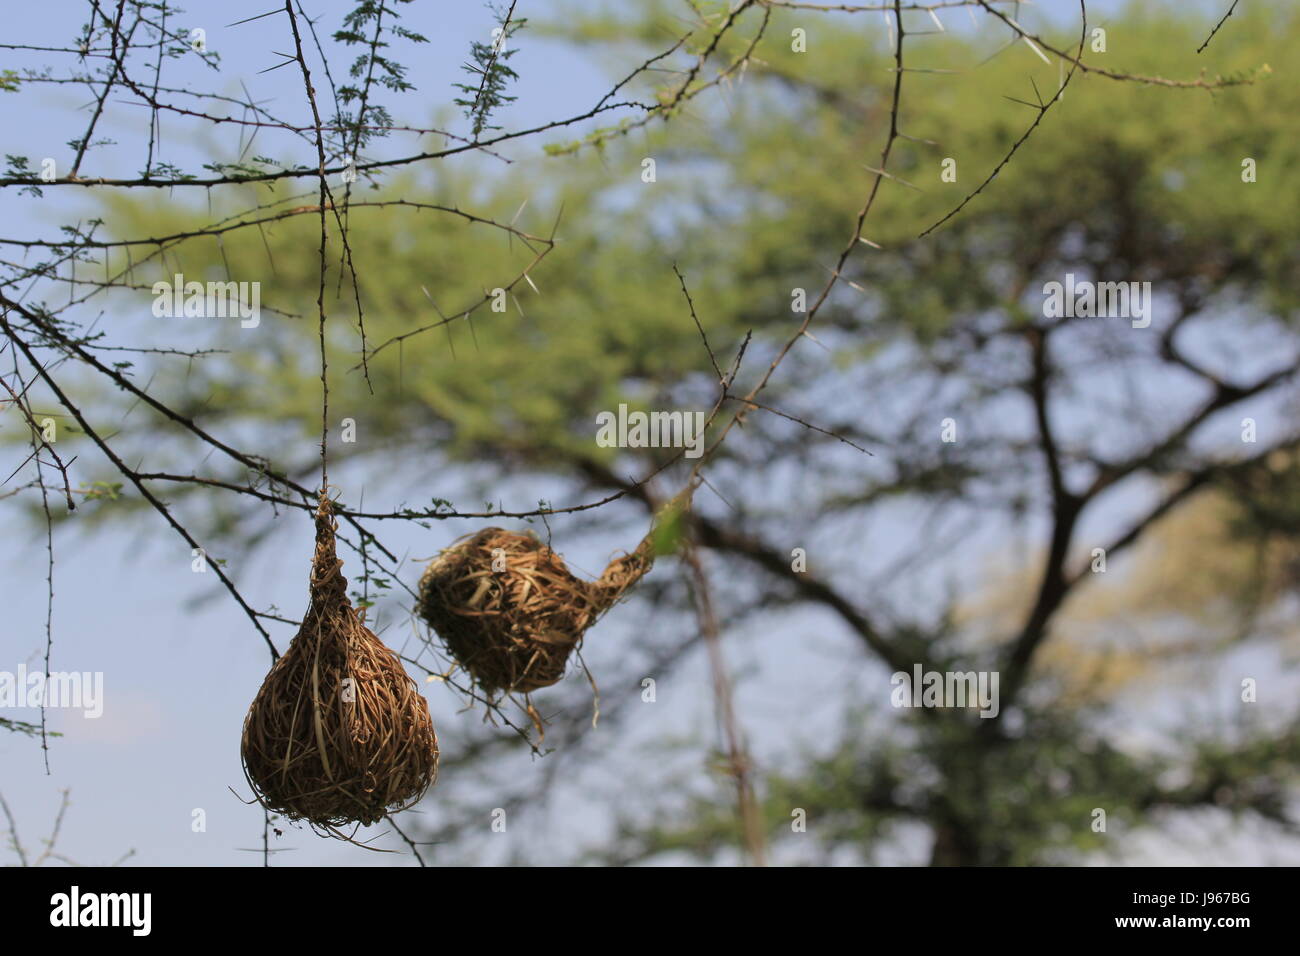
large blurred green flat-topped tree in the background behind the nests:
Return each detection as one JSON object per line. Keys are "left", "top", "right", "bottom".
{"left": 10, "top": 3, "right": 1300, "bottom": 864}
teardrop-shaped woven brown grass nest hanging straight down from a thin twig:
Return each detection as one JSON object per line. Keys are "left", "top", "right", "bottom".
{"left": 242, "top": 494, "right": 438, "bottom": 829}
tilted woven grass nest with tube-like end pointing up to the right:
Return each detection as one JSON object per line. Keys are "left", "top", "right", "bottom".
{"left": 417, "top": 498, "right": 683, "bottom": 693}
